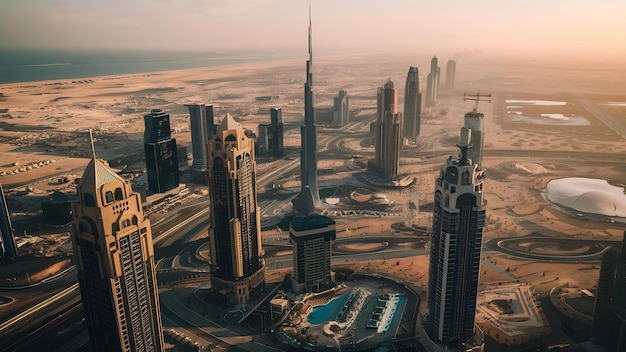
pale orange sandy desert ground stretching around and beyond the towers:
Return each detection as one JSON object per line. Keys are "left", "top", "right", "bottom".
{"left": 0, "top": 56, "right": 626, "bottom": 291}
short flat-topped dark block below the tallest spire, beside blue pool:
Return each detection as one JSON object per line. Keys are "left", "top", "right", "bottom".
{"left": 289, "top": 215, "right": 337, "bottom": 293}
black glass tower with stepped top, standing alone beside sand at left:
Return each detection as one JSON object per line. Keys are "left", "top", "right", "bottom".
{"left": 143, "top": 109, "right": 180, "bottom": 193}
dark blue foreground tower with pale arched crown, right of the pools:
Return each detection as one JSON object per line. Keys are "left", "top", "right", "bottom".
{"left": 425, "top": 127, "right": 485, "bottom": 347}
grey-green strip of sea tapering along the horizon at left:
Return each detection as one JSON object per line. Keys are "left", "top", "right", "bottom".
{"left": 0, "top": 50, "right": 290, "bottom": 83}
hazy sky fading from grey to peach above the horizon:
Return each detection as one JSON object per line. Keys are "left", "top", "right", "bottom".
{"left": 0, "top": 0, "right": 626, "bottom": 56}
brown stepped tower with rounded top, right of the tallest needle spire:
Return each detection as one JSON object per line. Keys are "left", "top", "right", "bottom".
{"left": 368, "top": 79, "right": 402, "bottom": 181}
